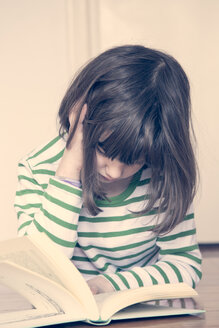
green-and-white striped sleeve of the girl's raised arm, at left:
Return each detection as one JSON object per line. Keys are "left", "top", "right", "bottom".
{"left": 14, "top": 155, "right": 82, "bottom": 258}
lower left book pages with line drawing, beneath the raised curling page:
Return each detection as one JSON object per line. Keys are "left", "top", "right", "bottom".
{"left": 0, "top": 262, "right": 86, "bottom": 328}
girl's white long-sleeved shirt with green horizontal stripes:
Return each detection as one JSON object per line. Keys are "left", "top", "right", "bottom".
{"left": 14, "top": 137, "right": 201, "bottom": 290}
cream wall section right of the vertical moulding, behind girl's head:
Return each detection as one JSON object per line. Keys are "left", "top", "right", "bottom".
{"left": 95, "top": 0, "right": 219, "bottom": 242}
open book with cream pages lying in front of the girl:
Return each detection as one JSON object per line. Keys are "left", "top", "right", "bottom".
{"left": 0, "top": 233, "right": 203, "bottom": 328}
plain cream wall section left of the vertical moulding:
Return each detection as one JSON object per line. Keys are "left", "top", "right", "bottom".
{"left": 0, "top": 0, "right": 69, "bottom": 239}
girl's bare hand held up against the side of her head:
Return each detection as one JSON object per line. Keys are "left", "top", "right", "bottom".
{"left": 56, "top": 104, "right": 87, "bottom": 181}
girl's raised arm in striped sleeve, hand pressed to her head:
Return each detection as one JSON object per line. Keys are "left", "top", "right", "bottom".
{"left": 15, "top": 105, "right": 87, "bottom": 258}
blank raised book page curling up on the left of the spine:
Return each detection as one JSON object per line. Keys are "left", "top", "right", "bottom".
{"left": 0, "top": 232, "right": 99, "bottom": 320}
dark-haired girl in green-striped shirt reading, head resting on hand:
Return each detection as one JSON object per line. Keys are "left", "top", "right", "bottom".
{"left": 15, "top": 45, "right": 201, "bottom": 293}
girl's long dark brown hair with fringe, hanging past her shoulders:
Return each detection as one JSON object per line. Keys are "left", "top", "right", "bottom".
{"left": 59, "top": 45, "right": 196, "bottom": 233}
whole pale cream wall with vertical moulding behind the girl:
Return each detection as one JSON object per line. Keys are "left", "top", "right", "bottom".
{"left": 0, "top": 0, "right": 219, "bottom": 243}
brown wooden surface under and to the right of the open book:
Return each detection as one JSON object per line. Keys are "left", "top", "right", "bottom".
{"left": 0, "top": 246, "right": 219, "bottom": 328}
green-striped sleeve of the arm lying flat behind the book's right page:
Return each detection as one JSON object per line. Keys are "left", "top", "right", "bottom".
{"left": 101, "top": 213, "right": 202, "bottom": 290}
